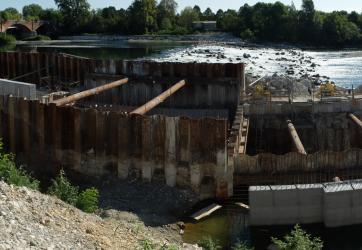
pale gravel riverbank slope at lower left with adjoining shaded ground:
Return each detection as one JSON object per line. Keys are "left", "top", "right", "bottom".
{"left": 0, "top": 177, "right": 198, "bottom": 249}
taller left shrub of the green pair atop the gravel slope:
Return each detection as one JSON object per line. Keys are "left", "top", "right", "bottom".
{"left": 48, "top": 170, "right": 79, "bottom": 206}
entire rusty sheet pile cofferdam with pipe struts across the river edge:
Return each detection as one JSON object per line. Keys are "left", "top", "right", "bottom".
{"left": 0, "top": 49, "right": 362, "bottom": 216}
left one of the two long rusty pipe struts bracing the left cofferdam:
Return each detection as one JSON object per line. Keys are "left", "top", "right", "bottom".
{"left": 53, "top": 78, "right": 128, "bottom": 106}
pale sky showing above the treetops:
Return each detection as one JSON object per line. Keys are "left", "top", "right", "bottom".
{"left": 0, "top": 0, "right": 362, "bottom": 12}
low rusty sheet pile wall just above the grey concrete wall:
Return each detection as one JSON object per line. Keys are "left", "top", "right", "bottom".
{"left": 233, "top": 149, "right": 362, "bottom": 185}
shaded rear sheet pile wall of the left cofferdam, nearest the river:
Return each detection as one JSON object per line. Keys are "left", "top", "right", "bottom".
{"left": 0, "top": 52, "right": 244, "bottom": 109}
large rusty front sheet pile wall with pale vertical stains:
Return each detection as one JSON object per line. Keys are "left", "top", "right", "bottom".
{"left": 0, "top": 96, "right": 232, "bottom": 198}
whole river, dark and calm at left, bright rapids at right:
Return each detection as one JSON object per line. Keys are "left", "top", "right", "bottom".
{"left": 9, "top": 40, "right": 362, "bottom": 88}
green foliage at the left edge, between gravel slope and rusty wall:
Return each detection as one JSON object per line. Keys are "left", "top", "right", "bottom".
{"left": 0, "top": 141, "right": 39, "bottom": 190}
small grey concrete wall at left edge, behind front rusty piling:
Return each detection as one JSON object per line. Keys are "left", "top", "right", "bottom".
{"left": 0, "top": 79, "right": 37, "bottom": 100}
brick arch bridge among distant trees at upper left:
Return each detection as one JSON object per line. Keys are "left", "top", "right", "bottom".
{"left": 0, "top": 20, "right": 48, "bottom": 33}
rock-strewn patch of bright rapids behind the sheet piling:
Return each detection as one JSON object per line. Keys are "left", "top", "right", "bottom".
{"left": 156, "top": 45, "right": 329, "bottom": 80}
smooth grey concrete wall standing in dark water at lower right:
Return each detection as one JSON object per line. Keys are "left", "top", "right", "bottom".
{"left": 249, "top": 180, "right": 362, "bottom": 227}
